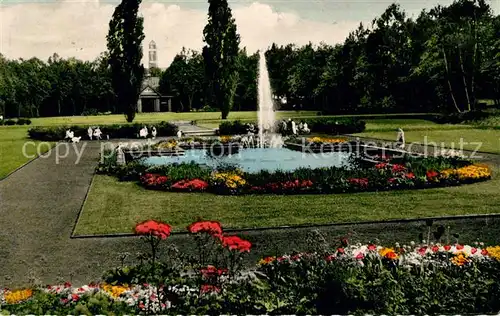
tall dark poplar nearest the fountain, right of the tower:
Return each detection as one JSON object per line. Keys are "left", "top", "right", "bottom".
{"left": 203, "top": 0, "right": 240, "bottom": 119}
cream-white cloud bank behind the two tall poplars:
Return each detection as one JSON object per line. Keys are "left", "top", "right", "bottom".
{"left": 0, "top": 0, "right": 359, "bottom": 67}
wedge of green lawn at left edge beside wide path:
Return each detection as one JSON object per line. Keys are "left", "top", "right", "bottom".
{"left": 0, "top": 126, "right": 54, "bottom": 179}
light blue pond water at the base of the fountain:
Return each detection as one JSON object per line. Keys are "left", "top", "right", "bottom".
{"left": 141, "top": 148, "right": 351, "bottom": 173}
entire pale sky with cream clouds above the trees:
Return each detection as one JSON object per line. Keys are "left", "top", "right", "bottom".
{"left": 0, "top": 0, "right": 500, "bottom": 68}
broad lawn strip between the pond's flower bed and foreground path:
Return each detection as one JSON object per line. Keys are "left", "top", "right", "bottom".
{"left": 75, "top": 164, "right": 500, "bottom": 235}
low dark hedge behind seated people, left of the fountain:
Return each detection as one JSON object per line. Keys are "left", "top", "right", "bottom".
{"left": 28, "top": 122, "right": 177, "bottom": 141}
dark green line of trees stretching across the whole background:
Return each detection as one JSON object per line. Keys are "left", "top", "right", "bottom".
{"left": 0, "top": 0, "right": 500, "bottom": 117}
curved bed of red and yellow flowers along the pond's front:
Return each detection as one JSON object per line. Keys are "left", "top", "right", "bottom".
{"left": 98, "top": 150, "right": 491, "bottom": 195}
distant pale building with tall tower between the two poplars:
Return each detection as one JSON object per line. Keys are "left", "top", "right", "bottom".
{"left": 137, "top": 41, "right": 172, "bottom": 113}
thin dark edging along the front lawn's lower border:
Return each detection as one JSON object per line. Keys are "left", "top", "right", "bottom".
{"left": 71, "top": 213, "right": 500, "bottom": 239}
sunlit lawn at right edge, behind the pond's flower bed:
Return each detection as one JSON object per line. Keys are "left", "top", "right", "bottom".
{"left": 357, "top": 128, "right": 500, "bottom": 154}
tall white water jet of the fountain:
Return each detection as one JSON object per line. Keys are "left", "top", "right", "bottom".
{"left": 257, "top": 50, "right": 283, "bottom": 148}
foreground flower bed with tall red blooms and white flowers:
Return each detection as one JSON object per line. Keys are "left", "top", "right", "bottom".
{"left": 0, "top": 220, "right": 500, "bottom": 315}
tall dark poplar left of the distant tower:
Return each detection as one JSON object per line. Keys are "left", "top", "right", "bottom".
{"left": 107, "top": 0, "right": 144, "bottom": 122}
